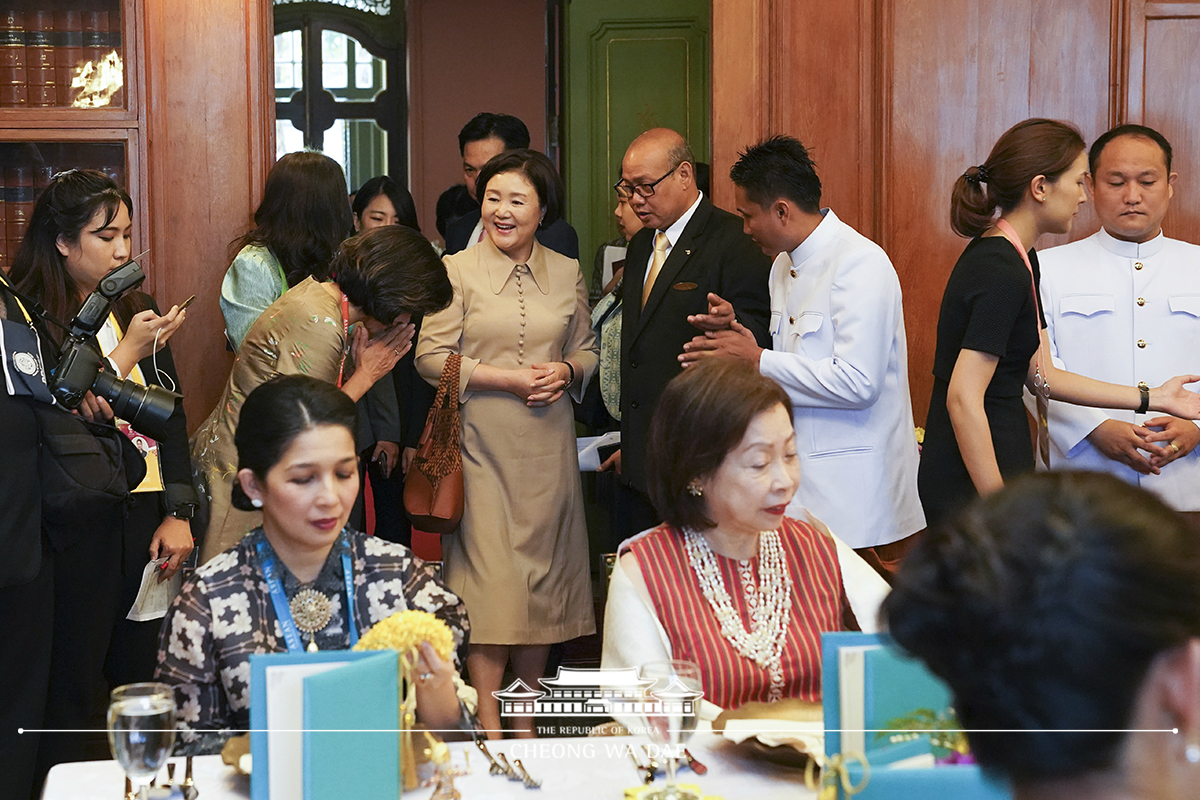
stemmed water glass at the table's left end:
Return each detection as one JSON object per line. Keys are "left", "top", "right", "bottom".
{"left": 108, "top": 684, "right": 175, "bottom": 800}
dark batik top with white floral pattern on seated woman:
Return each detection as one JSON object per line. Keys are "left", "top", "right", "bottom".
{"left": 155, "top": 529, "right": 470, "bottom": 754}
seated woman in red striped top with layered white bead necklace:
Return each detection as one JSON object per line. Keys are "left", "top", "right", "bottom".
{"left": 604, "top": 359, "right": 887, "bottom": 718}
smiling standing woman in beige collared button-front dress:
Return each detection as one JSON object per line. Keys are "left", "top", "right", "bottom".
{"left": 416, "top": 150, "right": 598, "bottom": 738}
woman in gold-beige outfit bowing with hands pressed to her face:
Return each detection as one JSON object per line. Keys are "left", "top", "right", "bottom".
{"left": 192, "top": 225, "right": 450, "bottom": 564}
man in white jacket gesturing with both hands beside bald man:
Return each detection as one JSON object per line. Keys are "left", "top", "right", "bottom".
{"left": 680, "top": 137, "right": 925, "bottom": 566}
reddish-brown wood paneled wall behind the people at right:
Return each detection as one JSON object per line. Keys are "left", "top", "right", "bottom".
{"left": 713, "top": 0, "right": 1200, "bottom": 423}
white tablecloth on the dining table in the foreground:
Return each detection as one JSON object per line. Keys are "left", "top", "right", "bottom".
{"left": 42, "top": 734, "right": 816, "bottom": 800}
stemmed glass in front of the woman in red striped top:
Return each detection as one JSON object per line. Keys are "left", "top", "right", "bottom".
{"left": 642, "top": 658, "right": 704, "bottom": 800}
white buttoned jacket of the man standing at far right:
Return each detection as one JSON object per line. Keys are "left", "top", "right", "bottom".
{"left": 1038, "top": 229, "right": 1200, "bottom": 511}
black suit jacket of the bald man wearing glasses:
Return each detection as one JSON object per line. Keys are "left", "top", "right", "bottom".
{"left": 620, "top": 198, "right": 770, "bottom": 494}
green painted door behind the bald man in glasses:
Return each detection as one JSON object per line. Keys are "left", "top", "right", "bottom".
{"left": 563, "top": 0, "right": 712, "bottom": 284}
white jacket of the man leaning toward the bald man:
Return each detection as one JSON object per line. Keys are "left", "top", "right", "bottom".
{"left": 758, "top": 209, "right": 925, "bottom": 548}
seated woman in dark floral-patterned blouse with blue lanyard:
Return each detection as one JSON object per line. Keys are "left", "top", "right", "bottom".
{"left": 156, "top": 375, "right": 475, "bottom": 754}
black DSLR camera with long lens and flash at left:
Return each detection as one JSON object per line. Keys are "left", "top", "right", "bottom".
{"left": 49, "top": 261, "right": 182, "bottom": 439}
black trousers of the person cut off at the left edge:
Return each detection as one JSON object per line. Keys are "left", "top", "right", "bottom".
{"left": 0, "top": 546, "right": 54, "bottom": 800}
